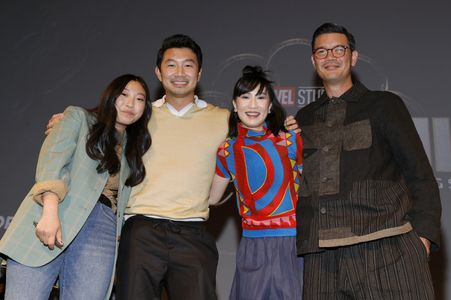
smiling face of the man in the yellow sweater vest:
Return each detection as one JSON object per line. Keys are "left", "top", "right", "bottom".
{"left": 155, "top": 48, "right": 201, "bottom": 101}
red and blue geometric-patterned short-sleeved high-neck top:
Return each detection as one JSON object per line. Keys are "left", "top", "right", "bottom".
{"left": 216, "top": 127, "right": 302, "bottom": 236}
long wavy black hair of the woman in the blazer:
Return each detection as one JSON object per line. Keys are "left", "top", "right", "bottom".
{"left": 86, "top": 74, "right": 152, "bottom": 186}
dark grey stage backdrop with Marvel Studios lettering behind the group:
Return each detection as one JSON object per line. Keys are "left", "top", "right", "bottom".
{"left": 0, "top": 0, "right": 451, "bottom": 299}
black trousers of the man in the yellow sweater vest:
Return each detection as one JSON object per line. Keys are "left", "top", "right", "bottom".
{"left": 116, "top": 216, "right": 218, "bottom": 300}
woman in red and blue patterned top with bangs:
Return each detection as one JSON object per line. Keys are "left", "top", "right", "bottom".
{"left": 209, "top": 66, "right": 303, "bottom": 299}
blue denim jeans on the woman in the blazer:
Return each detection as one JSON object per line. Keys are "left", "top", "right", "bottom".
{"left": 5, "top": 203, "right": 116, "bottom": 300}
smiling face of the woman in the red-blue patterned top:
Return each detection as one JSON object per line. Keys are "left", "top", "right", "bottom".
{"left": 233, "top": 86, "right": 271, "bottom": 131}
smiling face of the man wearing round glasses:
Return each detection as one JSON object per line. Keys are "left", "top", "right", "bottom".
{"left": 312, "top": 33, "right": 358, "bottom": 85}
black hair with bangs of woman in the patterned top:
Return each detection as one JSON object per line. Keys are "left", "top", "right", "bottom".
{"left": 228, "top": 66, "right": 286, "bottom": 137}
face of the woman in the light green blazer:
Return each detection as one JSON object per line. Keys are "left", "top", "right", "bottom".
{"left": 114, "top": 80, "right": 146, "bottom": 132}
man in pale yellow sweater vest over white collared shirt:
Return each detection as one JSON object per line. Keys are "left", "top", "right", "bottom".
{"left": 116, "top": 35, "right": 228, "bottom": 300}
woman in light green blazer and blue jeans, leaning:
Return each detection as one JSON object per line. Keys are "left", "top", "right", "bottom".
{"left": 0, "top": 74, "right": 151, "bottom": 300}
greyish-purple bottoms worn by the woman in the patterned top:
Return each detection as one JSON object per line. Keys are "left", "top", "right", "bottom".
{"left": 229, "top": 236, "right": 304, "bottom": 300}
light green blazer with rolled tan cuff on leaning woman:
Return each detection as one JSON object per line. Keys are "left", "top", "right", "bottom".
{"left": 0, "top": 106, "right": 131, "bottom": 299}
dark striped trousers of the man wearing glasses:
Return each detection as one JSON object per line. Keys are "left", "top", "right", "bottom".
{"left": 304, "top": 231, "right": 434, "bottom": 300}
